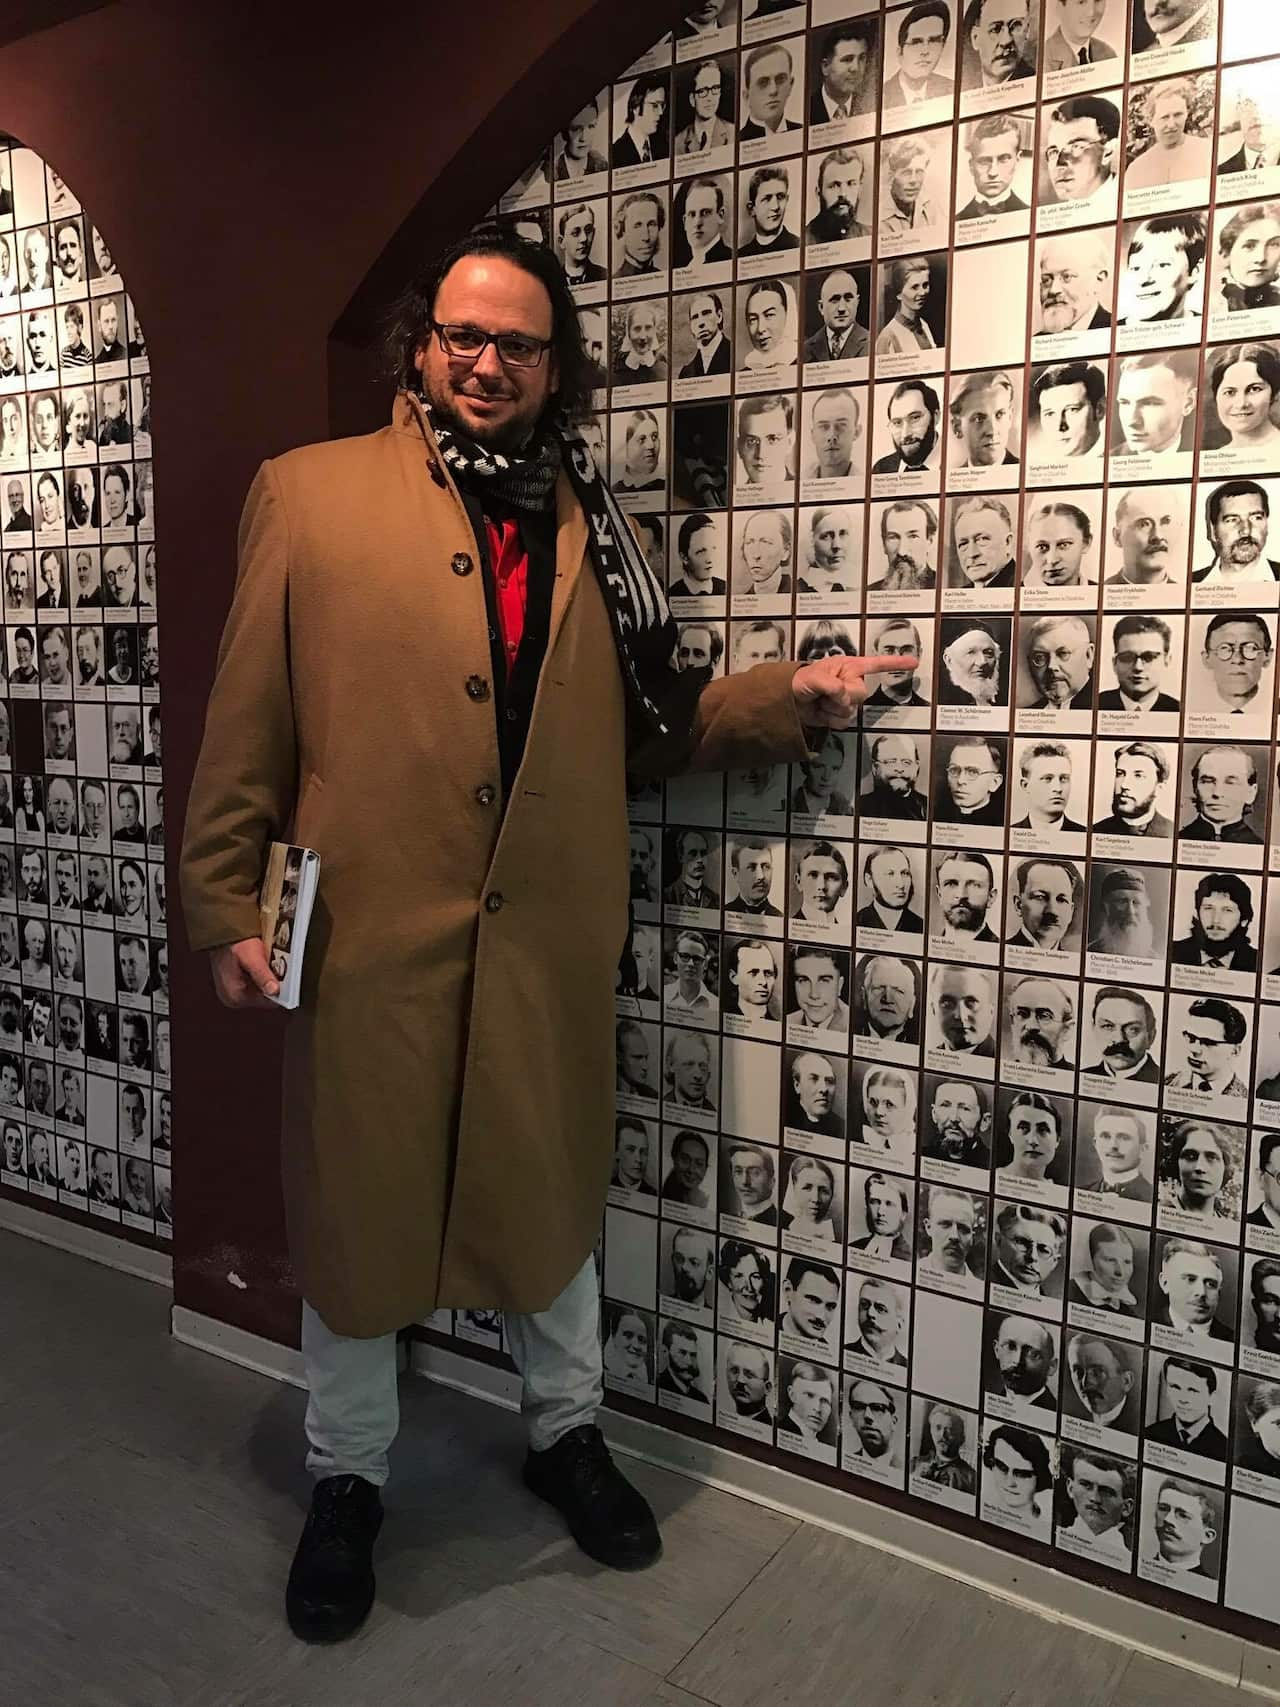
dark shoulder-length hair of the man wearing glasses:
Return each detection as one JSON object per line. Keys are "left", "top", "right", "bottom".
{"left": 387, "top": 220, "right": 592, "bottom": 420}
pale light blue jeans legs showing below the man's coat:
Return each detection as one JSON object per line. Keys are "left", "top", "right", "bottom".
{"left": 302, "top": 1256, "right": 604, "bottom": 1487}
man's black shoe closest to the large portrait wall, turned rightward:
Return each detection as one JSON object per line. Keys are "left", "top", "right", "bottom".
{"left": 524, "top": 1424, "right": 662, "bottom": 1570}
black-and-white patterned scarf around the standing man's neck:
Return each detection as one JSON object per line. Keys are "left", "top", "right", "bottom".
{"left": 418, "top": 394, "right": 701, "bottom": 746}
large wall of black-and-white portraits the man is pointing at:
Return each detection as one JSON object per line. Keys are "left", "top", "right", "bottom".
{"left": 423, "top": 0, "right": 1280, "bottom": 1623}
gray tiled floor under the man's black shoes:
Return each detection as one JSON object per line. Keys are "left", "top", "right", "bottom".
{"left": 0, "top": 1232, "right": 1256, "bottom": 1707}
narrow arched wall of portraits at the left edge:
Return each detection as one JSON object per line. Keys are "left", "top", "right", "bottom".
{"left": 0, "top": 135, "right": 172, "bottom": 1243}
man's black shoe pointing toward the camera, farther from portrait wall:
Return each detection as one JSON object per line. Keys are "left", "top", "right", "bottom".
{"left": 285, "top": 1477, "right": 382, "bottom": 1642}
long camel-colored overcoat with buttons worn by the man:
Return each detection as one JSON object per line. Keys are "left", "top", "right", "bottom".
{"left": 181, "top": 394, "right": 806, "bottom": 1337}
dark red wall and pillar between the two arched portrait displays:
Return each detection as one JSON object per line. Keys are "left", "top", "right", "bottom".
{"left": 0, "top": 0, "right": 683, "bottom": 1342}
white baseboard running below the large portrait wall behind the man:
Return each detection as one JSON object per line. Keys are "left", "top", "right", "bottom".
{"left": 410, "top": 1342, "right": 1280, "bottom": 1700}
